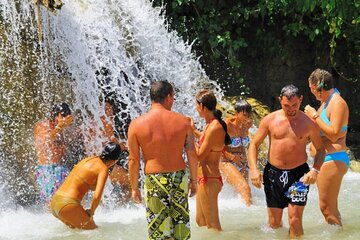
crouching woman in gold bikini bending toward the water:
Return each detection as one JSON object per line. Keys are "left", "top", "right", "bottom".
{"left": 50, "top": 142, "right": 121, "bottom": 230}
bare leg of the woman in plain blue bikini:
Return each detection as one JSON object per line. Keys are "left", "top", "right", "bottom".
{"left": 317, "top": 161, "right": 347, "bottom": 226}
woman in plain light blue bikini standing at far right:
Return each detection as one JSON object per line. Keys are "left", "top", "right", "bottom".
{"left": 305, "top": 69, "right": 350, "bottom": 226}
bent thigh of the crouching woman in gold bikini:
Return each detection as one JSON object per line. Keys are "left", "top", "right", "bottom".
{"left": 58, "top": 204, "right": 97, "bottom": 229}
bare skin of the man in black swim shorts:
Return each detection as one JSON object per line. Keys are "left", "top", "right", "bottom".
{"left": 249, "top": 96, "right": 325, "bottom": 237}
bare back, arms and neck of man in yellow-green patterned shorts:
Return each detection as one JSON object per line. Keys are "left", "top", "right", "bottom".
{"left": 128, "top": 94, "right": 197, "bottom": 203}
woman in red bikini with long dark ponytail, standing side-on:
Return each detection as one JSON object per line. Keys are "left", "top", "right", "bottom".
{"left": 193, "top": 90, "right": 230, "bottom": 231}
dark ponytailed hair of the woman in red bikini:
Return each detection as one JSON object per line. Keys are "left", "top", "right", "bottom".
{"left": 196, "top": 89, "right": 231, "bottom": 145}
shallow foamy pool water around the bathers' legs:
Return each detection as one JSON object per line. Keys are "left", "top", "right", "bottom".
{"left": 0, "top": 171, "right": 360, "bottom": 240}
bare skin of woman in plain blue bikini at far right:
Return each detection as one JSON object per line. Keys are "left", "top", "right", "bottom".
{"left": 305, "top": 81, "right": 349, "bottom": 226}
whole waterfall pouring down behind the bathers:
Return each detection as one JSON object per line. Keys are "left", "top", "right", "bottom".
{"left": 0, "top": 0, "right": 222, "bottom": 206}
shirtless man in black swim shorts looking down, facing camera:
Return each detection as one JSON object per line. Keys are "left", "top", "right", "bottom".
{"left": 249, "top": 85, "right": 325, "bottom": 237}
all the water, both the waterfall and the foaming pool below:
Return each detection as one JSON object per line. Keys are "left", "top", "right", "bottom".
{"left": 0, "top": 0, "right": 360, "bottom": 240}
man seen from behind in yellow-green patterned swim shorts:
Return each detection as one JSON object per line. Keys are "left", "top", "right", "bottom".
{"left": 128, "top": 81, "right": 197, "bottom": 239}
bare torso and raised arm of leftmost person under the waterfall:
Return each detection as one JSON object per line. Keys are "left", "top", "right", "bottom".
{"left": 34, "top": 113, "right": 73, "bottom": 165}
